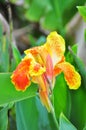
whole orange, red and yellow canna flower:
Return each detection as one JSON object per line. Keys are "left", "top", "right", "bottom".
{"left": 11, "top": 32, "right": 81, "bottom": 111}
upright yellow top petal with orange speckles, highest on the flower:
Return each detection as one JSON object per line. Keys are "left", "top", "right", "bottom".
{"left": 44, "top": 32, "right": 65, "bottom": 66}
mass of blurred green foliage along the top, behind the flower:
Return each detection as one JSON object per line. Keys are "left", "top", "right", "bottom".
{"left": 25, "top": 0, "right": 85, "bottom": 34}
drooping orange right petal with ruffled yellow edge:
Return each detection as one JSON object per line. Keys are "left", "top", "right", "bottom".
{"left": 58, "top": 62, "right": 81, "bottom": 89}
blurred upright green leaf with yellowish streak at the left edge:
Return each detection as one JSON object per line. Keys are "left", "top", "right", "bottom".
{"left": 0, "top": 23, "right": 9, "bottom": 72}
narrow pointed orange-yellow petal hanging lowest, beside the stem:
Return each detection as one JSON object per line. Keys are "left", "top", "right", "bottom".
{"left": 39, "top": 90, "right": 51, "bottom": 112}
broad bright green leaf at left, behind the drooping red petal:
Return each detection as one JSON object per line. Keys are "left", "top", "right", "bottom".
{"left": 0, "top": 73, "right": 37, "bottom": 106}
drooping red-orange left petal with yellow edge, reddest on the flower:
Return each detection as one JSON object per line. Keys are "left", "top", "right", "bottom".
{"left": 11, "top": 59, "right": 30, "bottom": 91}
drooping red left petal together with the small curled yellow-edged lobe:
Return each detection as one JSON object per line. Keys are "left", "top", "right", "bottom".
{"left": 11, "top": 54, "right": 46, "bottom": 91}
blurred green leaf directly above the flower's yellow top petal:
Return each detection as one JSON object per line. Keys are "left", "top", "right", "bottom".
{"left": 42, "top": 0, "right": 64, "bottom": 31}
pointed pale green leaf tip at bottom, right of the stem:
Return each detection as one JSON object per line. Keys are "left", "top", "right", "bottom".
{"left": 59, "top": 113, "right": 77, "bottom": 130}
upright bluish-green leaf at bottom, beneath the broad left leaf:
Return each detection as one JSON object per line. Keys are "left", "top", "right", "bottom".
{"left": 16, "top": 98, "right": 38, "bottom": 130}
